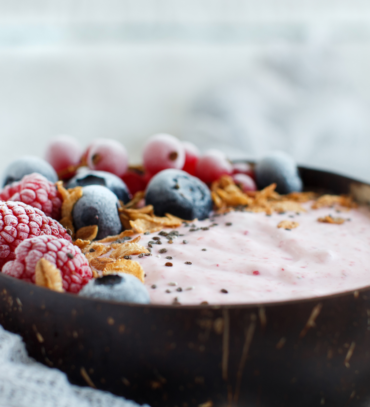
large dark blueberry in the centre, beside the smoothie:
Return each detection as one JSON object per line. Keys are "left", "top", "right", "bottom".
{"left": 145, "top": 169, "right": 212, "bottom": 220}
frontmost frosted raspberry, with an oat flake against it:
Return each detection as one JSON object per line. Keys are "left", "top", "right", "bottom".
{"left": 2, "top": 236, "right": 92, "bottom": 293}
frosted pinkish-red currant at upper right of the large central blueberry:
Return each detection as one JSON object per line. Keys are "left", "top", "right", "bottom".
{"left": 197, "top": 150, "right": 232, "bottom": 184}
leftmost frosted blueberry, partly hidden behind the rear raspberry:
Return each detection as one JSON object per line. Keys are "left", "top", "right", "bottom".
{"left": 1, "top": 156, "right": 58, "bottom": 187}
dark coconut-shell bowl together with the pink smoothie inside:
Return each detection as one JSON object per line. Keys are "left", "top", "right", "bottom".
{"left": 0, "top": 137, "right": 370, "bottom": 407}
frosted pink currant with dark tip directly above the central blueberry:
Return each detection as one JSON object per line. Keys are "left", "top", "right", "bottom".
{"left": 143, "top": 134, "right": 185, "bottom": 175}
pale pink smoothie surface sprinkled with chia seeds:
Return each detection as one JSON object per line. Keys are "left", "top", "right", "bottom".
{"left": 133, "top": 203, "right": 370, "bottom": 304}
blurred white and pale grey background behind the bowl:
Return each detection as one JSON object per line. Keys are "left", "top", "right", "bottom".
{"left": 0, "top": 0, "right": 370, "bottom": 180}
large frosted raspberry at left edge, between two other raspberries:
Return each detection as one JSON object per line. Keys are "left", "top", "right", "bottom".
{"left": 0, "top": 201, "right": 71, "bottom": 269}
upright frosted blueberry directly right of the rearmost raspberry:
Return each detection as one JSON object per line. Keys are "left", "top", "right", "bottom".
{"left": 72, "top": 185, "right": 122, "bottom": 239}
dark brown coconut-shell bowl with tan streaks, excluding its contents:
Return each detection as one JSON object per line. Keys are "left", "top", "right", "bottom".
{"left": 0, "top": 168, "right": 370, "bottom": 407}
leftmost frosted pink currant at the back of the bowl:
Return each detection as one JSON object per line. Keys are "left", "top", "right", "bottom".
{"left": 45, "top": 135, "right": 82, "bottom": 179}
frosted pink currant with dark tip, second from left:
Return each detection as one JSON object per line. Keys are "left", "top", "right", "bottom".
{"left": 87, "top": 139, "right": 128, "bottom": 177}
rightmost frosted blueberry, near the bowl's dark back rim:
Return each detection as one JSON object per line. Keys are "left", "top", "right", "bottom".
{"left": 255, "top": 151, "right": 302, "bottom": 194}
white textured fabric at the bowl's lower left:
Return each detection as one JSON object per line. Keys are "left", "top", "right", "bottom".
{"left": 0, "top": 326, "right": 148, "bottom": 407}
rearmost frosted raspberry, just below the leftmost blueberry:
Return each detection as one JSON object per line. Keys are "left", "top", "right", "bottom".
{"left": 0, "top": 173, "right": 62, "bottom": 219}
